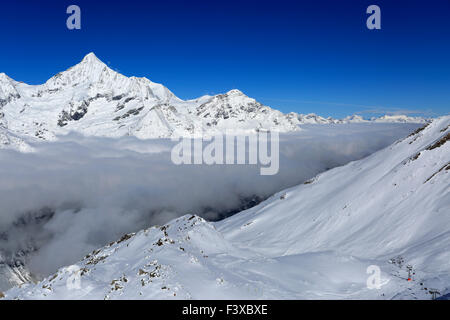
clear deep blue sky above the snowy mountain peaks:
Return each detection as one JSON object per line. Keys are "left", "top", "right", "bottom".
{"left": 0, "top": 0, "right": 450, "bottom": 117}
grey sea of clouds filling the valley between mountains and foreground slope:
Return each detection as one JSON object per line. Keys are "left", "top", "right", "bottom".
{"left": 0, "top": 124, "right": 419, "bottom": 276}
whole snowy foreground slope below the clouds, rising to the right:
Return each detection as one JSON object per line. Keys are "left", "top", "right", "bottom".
{"left": 5, "top": 115, "right": 450, "bottom": 299}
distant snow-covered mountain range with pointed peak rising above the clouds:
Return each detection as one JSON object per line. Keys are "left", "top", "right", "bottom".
{"left": 0, "top": 53, "right": 424, "bottom": 151}
